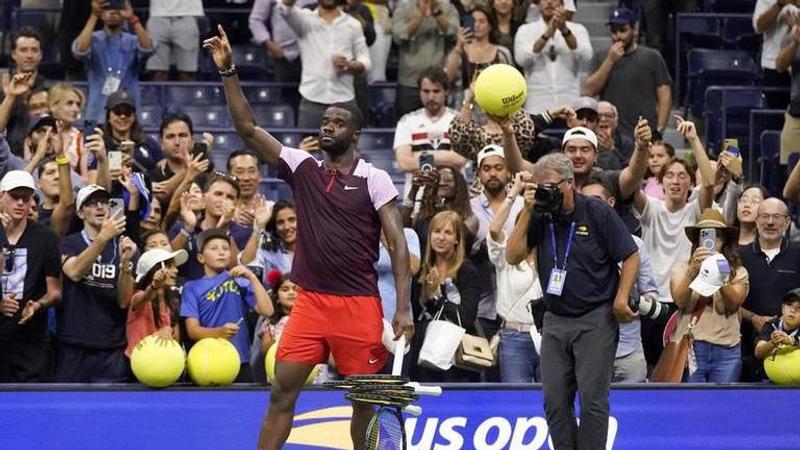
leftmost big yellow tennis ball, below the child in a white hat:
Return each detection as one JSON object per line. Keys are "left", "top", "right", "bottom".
{"left": 131, "top": 335, "right": 186, "bottom": 388}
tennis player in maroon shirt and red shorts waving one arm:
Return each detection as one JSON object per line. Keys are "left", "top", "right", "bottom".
{"left": 203, "top": 27, "right": 414, "bottom": 450}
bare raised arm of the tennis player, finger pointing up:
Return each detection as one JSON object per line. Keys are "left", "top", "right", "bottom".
{"left": 203, "top": 25, "right": 283, "bottom": 165}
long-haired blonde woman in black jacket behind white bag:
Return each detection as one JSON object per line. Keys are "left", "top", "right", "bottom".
{"left": 411, "top": 211, "right": 481, "bottom": 382}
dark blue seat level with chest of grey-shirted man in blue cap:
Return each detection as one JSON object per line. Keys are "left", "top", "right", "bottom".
{"left": 686, "top": 48, "right": 760, "bottom": 117}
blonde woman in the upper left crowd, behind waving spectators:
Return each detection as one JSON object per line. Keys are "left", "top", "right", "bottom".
{"left": 47, "top": 83, "right": 93, "bottom": 183}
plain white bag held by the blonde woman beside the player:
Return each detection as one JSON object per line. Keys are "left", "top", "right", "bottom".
{"left": 417, "top": 302, "right": 467, "bottom": 371}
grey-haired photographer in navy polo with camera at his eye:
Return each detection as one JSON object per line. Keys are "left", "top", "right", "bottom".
{"left": 506, "top": 154, "right": 639, "bottom": 448}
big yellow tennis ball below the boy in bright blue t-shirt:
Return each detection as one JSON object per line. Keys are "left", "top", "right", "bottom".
{"left": 186, "top": 338, "right": 242, "bottom": 386}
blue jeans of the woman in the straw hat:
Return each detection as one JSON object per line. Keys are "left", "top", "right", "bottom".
{"left": 689, "top": 341, "right": 742, "bottom": 383}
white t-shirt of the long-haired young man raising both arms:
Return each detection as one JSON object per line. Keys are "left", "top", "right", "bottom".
{"left": 634, "top": 196, "right": 700, "bottom": 303}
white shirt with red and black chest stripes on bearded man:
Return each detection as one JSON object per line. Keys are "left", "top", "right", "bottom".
{"left": 392, "top": 108, "right": 456, "bottom": 198}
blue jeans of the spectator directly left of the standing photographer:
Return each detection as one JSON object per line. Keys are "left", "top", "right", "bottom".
{"left": 499, "top": 330, "right": 540, "bottom": 383}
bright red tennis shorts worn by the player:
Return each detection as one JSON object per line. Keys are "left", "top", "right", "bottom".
{"left": 276, "top": 286, "right": 388, "bottom": 375}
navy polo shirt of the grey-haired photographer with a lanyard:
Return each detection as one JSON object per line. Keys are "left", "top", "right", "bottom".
{"left": 528, "top": 193, "right": 637, "bottom": 317}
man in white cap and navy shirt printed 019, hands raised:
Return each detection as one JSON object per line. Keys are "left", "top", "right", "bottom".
{"left": 55, "top": 184, "right": 136, "bottom": 383}
